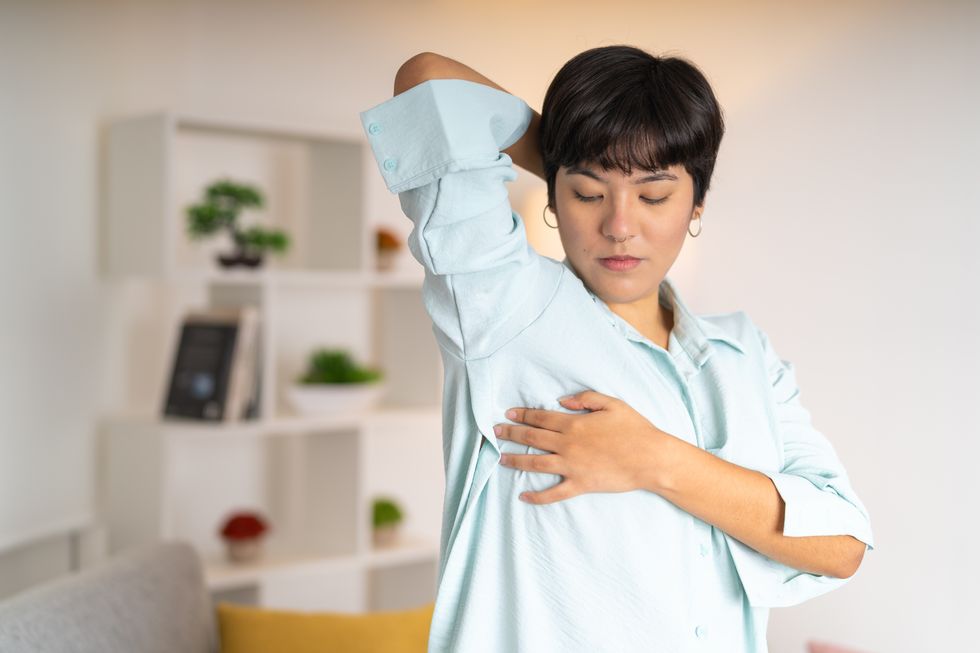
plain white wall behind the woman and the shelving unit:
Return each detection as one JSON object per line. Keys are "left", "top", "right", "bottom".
{"left": 0, "top": 0, "right": 980, "bottom": 653}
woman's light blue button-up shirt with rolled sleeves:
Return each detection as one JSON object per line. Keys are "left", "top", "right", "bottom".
{"left": 360, "top": 79, "right": 873, "bottom": 653}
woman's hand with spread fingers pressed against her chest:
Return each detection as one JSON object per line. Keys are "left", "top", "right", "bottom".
{"left": 494, "top": 390, "right": 673, "bottom": 504}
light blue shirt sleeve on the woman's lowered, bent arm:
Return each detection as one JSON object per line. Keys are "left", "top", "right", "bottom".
{"left": 728, "top": 328, "right": 874, "bottom": 607}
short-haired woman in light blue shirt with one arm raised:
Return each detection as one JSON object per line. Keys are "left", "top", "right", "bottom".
{"left": 361, "top": 46, "right": 873, "bottom": 653}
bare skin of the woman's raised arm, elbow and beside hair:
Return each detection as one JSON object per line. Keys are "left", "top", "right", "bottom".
{"left": 394, "top": 52, "right": 544, "bottom": 179}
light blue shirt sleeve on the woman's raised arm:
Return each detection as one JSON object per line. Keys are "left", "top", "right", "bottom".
{"left": 360, "top": 79, "right": 561, "bottom": 359}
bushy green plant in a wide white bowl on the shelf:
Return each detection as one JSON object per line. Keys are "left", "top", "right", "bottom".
{"left": 288, "top": 349, "right": 384, "bottom": 415}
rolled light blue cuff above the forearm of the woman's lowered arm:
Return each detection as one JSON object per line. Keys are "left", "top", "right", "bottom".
{"left": 762, "top": 471, "right": 874, "bottom": 549}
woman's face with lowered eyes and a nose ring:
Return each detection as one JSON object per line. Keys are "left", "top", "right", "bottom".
{"left": 555, "top": 164, "right": 703, "bottom": 305}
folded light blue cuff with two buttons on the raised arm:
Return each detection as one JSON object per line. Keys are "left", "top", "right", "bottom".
{"left": 359, "top": 79, "right": 533, "bottom": 193}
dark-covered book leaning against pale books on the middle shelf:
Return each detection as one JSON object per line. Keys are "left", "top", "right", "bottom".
{"left": 163, "top": 306, "right": 259, "bottom": 422}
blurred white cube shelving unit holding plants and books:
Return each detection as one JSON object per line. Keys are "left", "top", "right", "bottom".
{"left": 100, "top": 114, "right": 444, "bottom": 612}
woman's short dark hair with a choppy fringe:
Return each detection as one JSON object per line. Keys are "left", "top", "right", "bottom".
{"left": 540, "top": 45, "right": 725, "bottom": 207}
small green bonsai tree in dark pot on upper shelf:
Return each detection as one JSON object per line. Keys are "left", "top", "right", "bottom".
{"left": 187, "top": 179, "right": 289, "bottom": 267}
